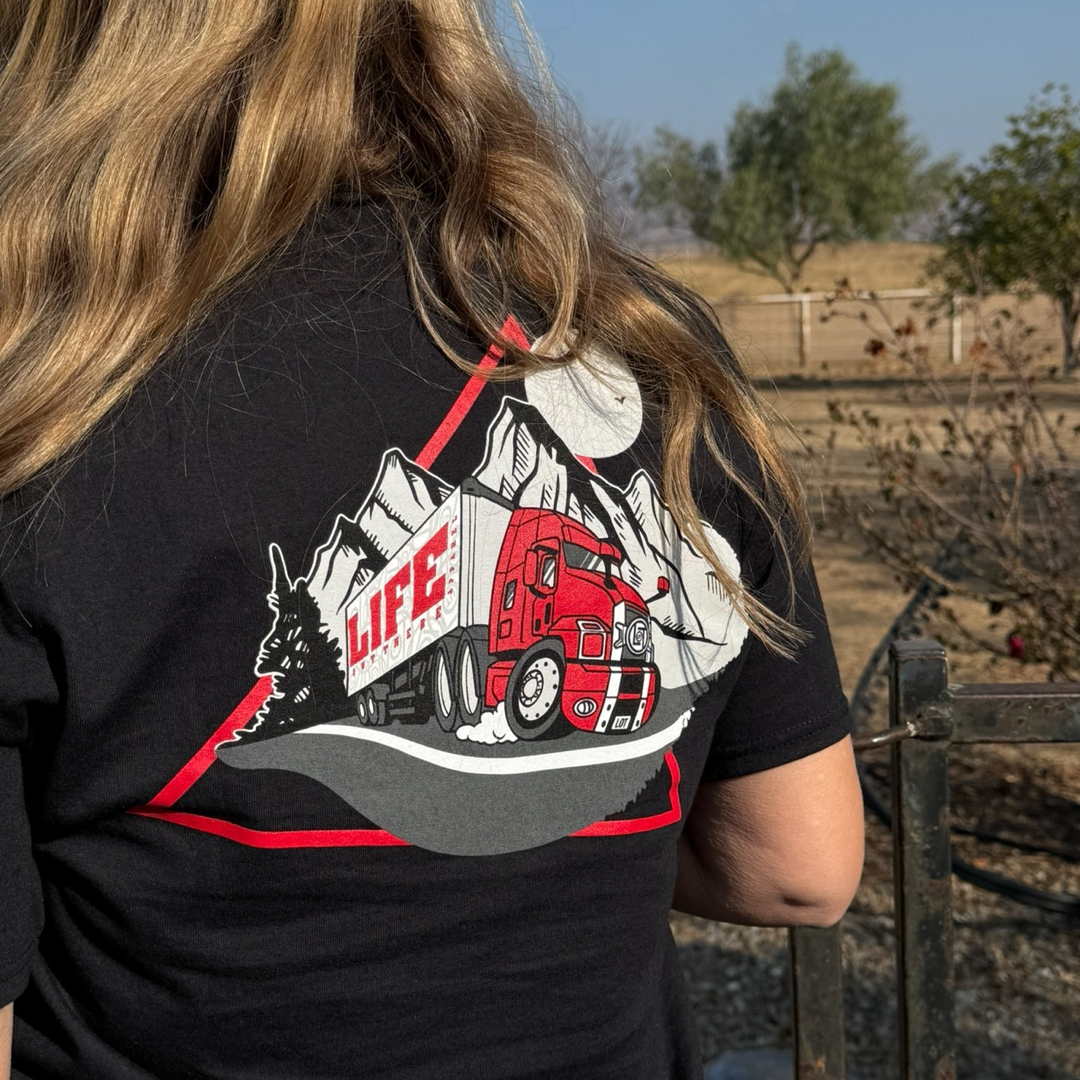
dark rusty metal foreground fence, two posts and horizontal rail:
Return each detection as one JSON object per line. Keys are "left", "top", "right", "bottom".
{"left": 791, "top": 640, "right": 1080, "bottom": 1080}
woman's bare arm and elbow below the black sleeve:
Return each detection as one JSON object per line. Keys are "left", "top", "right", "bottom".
{"left": 673, "top": 739, "right": 863, "bottom": 927}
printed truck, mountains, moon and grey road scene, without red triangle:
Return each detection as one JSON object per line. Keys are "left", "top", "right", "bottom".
{"left": 217, "top": 352, "right": 747, "bottom": 854}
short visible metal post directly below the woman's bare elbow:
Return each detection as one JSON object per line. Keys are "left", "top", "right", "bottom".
{"left": 788, "top": 923, "right": 847, "bottom": 1080}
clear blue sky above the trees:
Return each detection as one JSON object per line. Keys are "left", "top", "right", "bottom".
{"left": 522, "top": 0, "right": 1080, "bottom": 161}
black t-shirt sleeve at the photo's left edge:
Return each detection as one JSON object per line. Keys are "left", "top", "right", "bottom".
{"left": 0, "top": 596, "right": 49, "bottom": 1005}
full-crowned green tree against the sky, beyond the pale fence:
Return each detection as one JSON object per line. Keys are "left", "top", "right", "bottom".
{"left": 636, "top": 45, "right": 941, "bottom": 292}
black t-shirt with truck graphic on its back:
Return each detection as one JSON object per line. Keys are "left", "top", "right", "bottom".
{"left": 0, "top": 204, "right": 848, "bottom": 1080}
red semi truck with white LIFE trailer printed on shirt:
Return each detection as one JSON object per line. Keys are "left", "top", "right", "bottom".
{"left": 345, "top": 478, "right": 667, "bottom": 739}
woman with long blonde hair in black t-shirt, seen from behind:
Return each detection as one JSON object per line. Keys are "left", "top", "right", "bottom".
{"left": 0, "top": 0, "right": 862, "bottom": 1080}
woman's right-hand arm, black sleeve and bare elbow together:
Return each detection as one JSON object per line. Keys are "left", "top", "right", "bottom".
{"left": 675, "top": 442, "right": 863, "bottom": 924}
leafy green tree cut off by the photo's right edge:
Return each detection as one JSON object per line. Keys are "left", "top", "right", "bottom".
{"left": 930, "top": 85, "right": 1080, "bottom": 374}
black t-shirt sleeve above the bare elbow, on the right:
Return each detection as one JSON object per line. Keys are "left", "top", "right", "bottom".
{"left": 702, "top": 451, "right": 851, "bottom": 782}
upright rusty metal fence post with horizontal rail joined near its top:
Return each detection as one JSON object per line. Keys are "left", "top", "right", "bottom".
{"left": 889, "top": 642, "right": 956, "bottom": 1080}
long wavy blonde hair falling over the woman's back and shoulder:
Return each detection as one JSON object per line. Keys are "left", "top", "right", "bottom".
{"left": 0, "top": 0, "right": 807, "bottom": 651}
